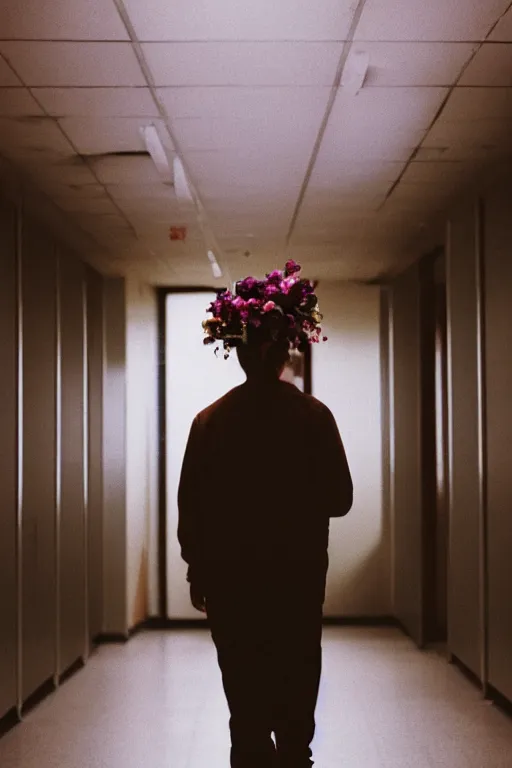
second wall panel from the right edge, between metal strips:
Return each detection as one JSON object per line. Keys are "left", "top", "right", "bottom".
{"left": 446, "top": 200, "right": 483, "bottom": 678}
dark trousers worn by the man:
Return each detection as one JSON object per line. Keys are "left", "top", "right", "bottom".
{"left": 203, "top": 566, "right": 325, "bottom": 768}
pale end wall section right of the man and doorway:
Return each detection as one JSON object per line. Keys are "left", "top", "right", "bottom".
{"left": 312, "top": 283, "right": 392, "bottom": 616}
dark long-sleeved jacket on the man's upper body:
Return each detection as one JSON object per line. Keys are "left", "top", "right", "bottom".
{"left": 178, "top": 380, "right": 353, "bottom": 579}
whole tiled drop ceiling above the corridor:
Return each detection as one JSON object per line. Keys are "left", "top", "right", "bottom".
{"left": 0, "top": 0, "right": 512, "bottom": 284}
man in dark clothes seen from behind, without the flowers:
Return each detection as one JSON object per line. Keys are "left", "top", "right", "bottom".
{"left": 178, "top": 266, "right": 352, "bottom": 768}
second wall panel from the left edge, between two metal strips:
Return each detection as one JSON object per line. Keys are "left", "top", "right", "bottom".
{"left": 20, "top": 217, "right": 60, "bottom": 700}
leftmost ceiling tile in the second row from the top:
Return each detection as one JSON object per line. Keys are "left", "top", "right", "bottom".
{"left": 0, "top": 42, "right": 146, "bottom": 87}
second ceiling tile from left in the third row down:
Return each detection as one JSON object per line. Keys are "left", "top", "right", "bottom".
{"left": 33, "top": 88, "right": 159, "bottom": 117}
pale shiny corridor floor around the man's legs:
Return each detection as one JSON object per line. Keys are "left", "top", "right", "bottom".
{"left": 0, "top": 628, "right": 512, "bottom": 768}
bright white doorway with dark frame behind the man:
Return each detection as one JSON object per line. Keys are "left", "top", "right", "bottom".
{"left": 158, "top": 287, "right": 312, "bottom": 622}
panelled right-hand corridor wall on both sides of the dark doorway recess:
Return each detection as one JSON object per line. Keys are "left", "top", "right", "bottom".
{"left": 393, "top": 171, "right": 512, "bottom": 701}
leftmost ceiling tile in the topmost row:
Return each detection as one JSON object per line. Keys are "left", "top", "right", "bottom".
{"left": 0, "top": 0, "right": 129, "bottom": 40}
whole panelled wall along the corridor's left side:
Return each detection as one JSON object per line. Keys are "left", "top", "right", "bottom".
{"left": 0, "top": 166, "right": 132, "bottom": 719}
